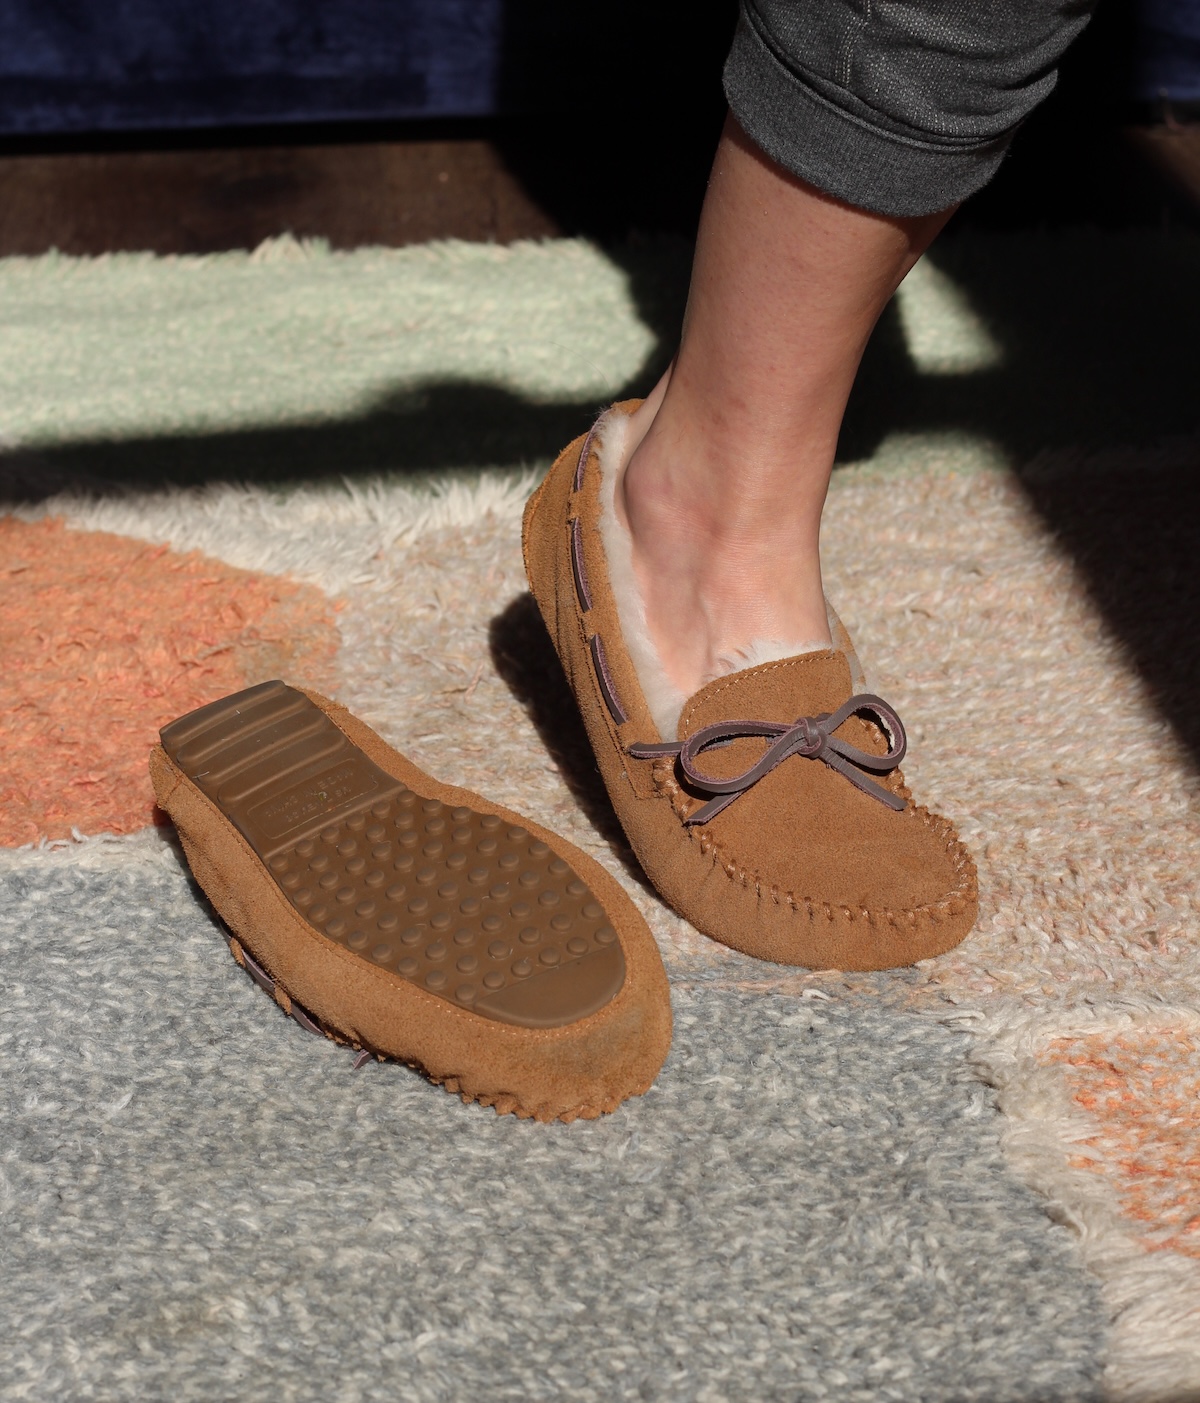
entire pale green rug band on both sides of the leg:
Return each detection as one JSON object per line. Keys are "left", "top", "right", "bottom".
{"left": 0, "top": 231, "right": 1200, "bottom": 495}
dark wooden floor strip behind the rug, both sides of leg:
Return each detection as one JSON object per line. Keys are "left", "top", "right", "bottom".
{"left": 0, "top": 123, "right": 1200, "bottom": 257}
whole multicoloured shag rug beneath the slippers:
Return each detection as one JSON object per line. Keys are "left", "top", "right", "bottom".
{"left": 0, "top": 234, "right": 1200, "bottom": 1403}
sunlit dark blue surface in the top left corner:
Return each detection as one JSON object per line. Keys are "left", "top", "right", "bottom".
{"left": 0, "top": 0, "right": 505, "bottom": 133}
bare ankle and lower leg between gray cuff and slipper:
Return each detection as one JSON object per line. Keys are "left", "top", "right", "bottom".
{"left": 618, "top": 118, "right": 953, "bottom": 694}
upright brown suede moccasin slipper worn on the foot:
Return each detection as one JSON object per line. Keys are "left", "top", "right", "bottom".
{"left": 524, "top": 401, "right": 977, "bottom": 969}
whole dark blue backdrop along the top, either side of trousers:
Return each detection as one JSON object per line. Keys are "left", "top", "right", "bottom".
{"left": 0, "top": 0, "right": 1200, "bottom": 136}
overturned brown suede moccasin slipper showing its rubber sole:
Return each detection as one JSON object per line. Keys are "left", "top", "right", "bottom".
{"left": 150, "top": 682, "right": 671, "bottom": 1121}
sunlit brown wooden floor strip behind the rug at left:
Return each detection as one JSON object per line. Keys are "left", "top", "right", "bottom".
{"left": 0, "top": 139, "right": 559, "bottom": 255}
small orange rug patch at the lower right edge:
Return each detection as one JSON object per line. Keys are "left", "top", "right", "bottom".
{"left": 1047, "top": 1030, "right": 1200, "bottom": 1257}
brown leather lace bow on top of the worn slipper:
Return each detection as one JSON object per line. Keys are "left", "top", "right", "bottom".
{"left": 629, "top": 692, "right": 908, "bottom": 825}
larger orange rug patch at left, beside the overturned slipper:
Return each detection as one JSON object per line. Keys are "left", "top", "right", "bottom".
{"left": 0, "top": 516, "right": 338, "bottom": 846}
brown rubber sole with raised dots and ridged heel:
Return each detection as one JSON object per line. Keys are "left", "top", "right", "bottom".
{"left": 161, "top": 682, "right": 625, "bottom": 1027}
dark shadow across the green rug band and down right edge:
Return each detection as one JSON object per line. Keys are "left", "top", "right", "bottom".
{"left": 0, "top": 231, "right": 1200, "bottom": 780}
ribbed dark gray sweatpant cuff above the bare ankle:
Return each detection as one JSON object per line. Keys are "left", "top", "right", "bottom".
{"left": 724, "top": 14, "right": 1013, "bottom": 216}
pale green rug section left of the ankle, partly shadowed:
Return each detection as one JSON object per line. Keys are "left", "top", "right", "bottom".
{"left": 0, "top": 239, "right": 676, "bottom": 495}
